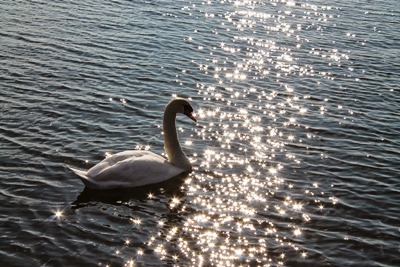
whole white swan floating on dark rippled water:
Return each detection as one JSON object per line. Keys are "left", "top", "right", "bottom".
{"left": 70, "top": 98, "right": 196, "bottom": 189}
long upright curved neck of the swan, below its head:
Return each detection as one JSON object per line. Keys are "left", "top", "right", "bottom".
{"left": 163, "top": 106, "right": 192, "bottom": 171}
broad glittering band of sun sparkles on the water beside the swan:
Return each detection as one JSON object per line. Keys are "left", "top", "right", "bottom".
{"left": 132, "top": 0, "right": 344, "bottom": 266}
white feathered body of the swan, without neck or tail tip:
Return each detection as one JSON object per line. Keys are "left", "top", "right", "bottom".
{"left": 87, "top": 150, "right": 184, "bottom": 188}
